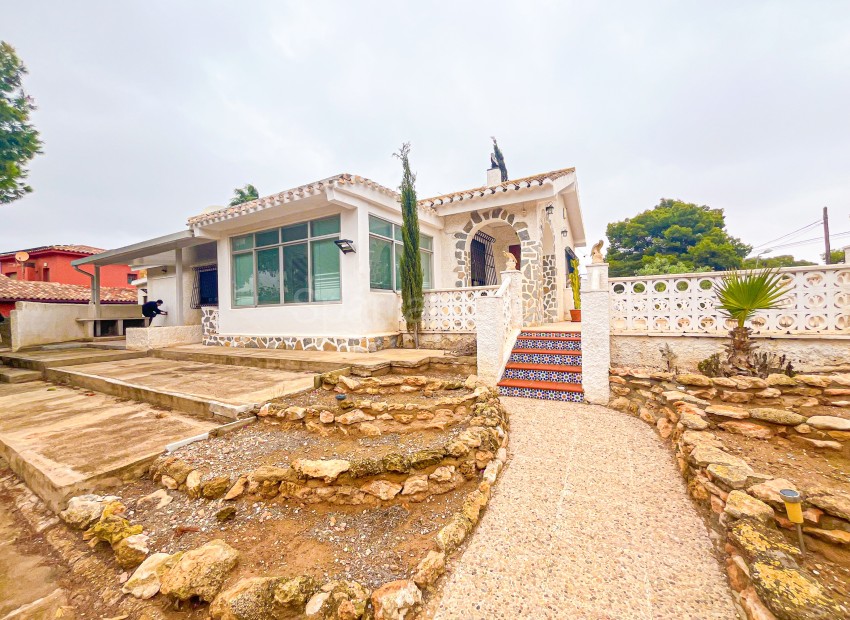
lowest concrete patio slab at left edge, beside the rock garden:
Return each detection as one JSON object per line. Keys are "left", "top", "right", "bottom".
{"left": 0, "top": 381, "right": 218, "bottom": 510}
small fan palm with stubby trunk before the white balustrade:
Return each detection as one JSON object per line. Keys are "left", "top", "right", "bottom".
{"left": 714, "top": 269, "right": 791, "bottom": 374}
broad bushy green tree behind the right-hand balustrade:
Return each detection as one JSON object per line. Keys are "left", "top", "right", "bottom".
{"left": 606, "top": 198, "right": 751, "bottom": 276}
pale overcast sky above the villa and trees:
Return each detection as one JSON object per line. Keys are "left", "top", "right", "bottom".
{"left": 0, "top": 0, "right": 850, "bottom": 259}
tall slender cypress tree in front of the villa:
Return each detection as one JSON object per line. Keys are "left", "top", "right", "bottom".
{"left": 395, "top": 142, "right": 425, "bottom": 349}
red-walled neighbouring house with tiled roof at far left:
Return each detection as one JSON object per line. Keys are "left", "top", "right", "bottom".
{"left": 0, "top": 245, "right": 136, "bottom": 289}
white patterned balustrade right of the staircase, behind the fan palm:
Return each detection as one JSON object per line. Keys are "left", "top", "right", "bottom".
{"left": 608, "top": 264, "right": 850, "bottom": 335}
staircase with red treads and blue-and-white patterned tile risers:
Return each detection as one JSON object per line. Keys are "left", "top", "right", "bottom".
{"left": 499, "top": 331, "right": 584, "bottom": 403}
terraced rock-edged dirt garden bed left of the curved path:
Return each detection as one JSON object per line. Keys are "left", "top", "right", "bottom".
{"left": 48, "top": 373, "right": 507, "bottom": 620}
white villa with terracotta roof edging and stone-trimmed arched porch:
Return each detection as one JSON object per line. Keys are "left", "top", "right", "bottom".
{"left": 71, "top": 162, "right": 585, "bottom": 351}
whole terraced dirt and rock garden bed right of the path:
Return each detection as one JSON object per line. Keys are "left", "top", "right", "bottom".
{"left": 610, "top": 369, "right": 850, "bottom": 620}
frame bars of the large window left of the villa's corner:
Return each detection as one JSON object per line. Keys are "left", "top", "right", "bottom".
{"left": 229, "top": 213, "right": 342, "bottom": 310}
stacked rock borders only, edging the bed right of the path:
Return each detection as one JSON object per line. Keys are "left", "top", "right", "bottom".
{"left": 609, "top": 369, "right": 850, "bottom": 620}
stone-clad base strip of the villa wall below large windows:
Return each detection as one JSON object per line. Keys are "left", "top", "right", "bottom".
{"left": 201, "top": 308, "right": 401, "bottom": 353}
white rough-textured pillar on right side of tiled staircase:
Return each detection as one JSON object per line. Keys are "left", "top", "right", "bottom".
{"left": 581, "top": 263, "right": 611, "bottom": 405}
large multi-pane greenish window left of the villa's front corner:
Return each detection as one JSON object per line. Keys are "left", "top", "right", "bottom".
{"left": 230, "top": 215, "right": 342, "bottom": 306}
